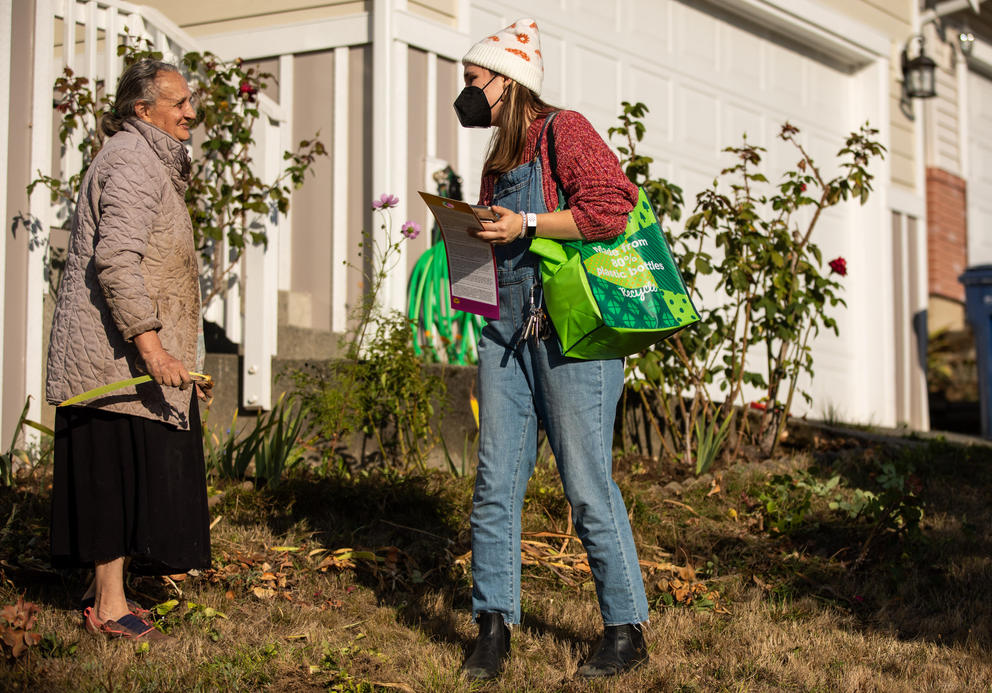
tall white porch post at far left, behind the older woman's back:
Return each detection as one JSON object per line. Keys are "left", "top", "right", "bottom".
{"left": 26, "top": 0, "right": 55, "bottom": 428}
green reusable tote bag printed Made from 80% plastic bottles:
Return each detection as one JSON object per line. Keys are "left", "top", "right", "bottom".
{"left": 530, "top": 116, "right": 699, "bottom": 359}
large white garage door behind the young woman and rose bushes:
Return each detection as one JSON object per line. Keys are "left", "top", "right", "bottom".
{"left": 467, "top": 0, "right": 868, "bottom": 420}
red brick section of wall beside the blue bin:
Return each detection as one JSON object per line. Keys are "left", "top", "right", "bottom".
{"left": 927, "top": 167, "right": 968, "bottom": 301}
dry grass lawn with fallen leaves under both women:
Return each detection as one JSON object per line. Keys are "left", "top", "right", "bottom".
{"left": 0, "top": 424, "right": 992, "bottom": 693}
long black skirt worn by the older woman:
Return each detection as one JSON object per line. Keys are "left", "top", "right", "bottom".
{"left": 51, "top": 388, "right": 210, "bottom": 575}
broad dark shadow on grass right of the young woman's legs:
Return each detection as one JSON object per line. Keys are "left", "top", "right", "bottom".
{"left": 631, "top": 435, "right": 992, "bottom": 648}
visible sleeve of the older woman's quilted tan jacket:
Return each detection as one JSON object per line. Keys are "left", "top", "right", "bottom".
{"left": 93, "top": 158, "right": 162, "bottom": 340}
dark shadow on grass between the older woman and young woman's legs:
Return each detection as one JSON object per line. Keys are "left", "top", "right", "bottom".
{"left": 232, "top": 471, "right": 480, "bottom": 647}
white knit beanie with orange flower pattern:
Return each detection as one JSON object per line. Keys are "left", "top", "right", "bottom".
{"left": 462, "top": 19, "right": 544, "bottom": 96}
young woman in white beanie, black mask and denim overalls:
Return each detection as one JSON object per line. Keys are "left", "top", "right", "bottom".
{"left": 455, "top": 19, "right": 648, "bottom": 679}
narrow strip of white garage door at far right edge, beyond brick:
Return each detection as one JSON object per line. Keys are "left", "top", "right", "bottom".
{"left": 967, "top": 72, "right": 992, "bottom": 266}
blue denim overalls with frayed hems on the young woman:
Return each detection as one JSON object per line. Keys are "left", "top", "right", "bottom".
{"left": 471, "top": 114, "right": 648, "bottom": 626}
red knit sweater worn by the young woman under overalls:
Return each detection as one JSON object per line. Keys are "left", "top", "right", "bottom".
{"left": 479, "top": 111, "right": 637, "bottom": 241}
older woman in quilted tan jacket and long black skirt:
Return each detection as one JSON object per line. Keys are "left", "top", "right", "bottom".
{"left": 46, "top": 60, "right": 210, "bottom": 641}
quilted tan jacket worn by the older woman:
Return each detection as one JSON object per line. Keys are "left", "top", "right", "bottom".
{"left": 46, "top": 118, "right": 200, "bottom": 429}
